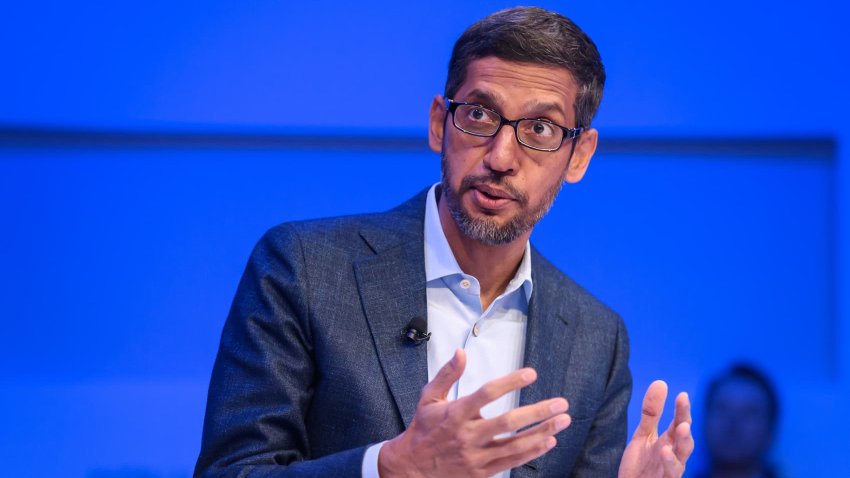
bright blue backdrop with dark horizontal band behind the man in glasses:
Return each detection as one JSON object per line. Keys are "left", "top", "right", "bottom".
{"left": 0, "top": 0, "right": 850, "bottom": 478}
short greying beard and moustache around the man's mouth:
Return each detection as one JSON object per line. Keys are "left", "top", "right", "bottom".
{"left": 440, "top": 153, "right": 564, "bottom": 246}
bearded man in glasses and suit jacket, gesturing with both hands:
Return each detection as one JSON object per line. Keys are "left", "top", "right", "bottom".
{"left": 196, "top": 8, "right": 693, "bottom": 478}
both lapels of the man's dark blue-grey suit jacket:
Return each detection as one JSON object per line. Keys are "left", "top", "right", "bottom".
{"left": 354, "top": 191, "right": 579, "bottom": 458}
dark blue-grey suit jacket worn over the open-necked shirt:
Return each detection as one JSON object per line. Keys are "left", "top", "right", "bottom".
{"left": 195, "top": 192, "right": 632, "bottom": 478}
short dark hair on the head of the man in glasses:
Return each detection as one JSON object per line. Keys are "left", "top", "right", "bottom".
{"left": 445, "top": 7, "right": 605, "bottom": 127}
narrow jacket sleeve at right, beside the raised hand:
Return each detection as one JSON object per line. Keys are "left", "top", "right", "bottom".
{"left": 570, "top": 316, "right": 632, "bottom": 478}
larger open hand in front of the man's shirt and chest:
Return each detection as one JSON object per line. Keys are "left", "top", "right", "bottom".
{"left": 378, "top": 349, "right": 570, "bottom": 478}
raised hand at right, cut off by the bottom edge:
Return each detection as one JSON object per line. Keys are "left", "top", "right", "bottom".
{"left": 618, "top": 380, "right": 694, "bottom": 478}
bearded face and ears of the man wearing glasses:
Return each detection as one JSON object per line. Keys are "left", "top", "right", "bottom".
{"left": 429, "top": 57, "right": 596, "bottom": 244}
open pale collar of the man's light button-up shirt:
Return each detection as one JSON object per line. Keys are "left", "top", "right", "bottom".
{"left": 425, "top": 183, "right": 533, "bottom": 301}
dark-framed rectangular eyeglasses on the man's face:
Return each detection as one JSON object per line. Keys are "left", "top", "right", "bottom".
{"left": 446, "top": 98, "right": 584, "bottom": 152}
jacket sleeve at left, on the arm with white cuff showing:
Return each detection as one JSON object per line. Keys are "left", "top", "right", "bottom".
{"left": 194, "top": 225, "right": 367, "bottom": 478}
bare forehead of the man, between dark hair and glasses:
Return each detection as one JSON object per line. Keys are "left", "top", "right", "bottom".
{"left": 454, "top": 57, "right": 578, "bottom": 119}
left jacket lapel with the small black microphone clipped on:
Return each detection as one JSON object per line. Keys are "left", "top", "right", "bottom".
{"left": 354, "top": 215, "right": 428, "bottom": 428}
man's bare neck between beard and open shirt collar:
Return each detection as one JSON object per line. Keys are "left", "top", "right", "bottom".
{"left": 437, "top": 191, "right": 531, "bottom": 310}
